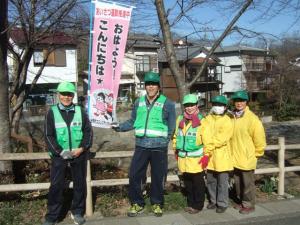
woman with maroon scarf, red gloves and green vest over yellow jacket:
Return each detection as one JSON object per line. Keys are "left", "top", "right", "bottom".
{"left": 173, "top": 94, "right": 208, "bottom": 214}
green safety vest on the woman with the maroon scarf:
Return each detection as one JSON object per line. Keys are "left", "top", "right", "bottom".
{"left": 176, "top": 114, "right": 203, "bottom": 158}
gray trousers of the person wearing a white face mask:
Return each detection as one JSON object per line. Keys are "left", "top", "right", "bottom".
{"left": 207, "top": 170, "right": 229, "bottom": 208}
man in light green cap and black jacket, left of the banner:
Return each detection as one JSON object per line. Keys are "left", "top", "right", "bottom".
{"left": 43, "top": 82, "right": 93, "bottom": 225}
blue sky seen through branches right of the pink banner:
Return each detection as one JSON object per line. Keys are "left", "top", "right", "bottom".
{"left": 89, "top": 0, "right": 300, "bottom": 45}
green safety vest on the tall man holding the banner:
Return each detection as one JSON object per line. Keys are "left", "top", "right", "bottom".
{"left": 133, "top": 95, "right": 168, "bottom": 138}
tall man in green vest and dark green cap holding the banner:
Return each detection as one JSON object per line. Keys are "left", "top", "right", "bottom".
{"left": 112, "top": 72, "right": 176, "bottom": 217}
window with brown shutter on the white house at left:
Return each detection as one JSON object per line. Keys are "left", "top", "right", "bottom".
{"left": 33, "top": 49, "right": 67, "bottom": 66}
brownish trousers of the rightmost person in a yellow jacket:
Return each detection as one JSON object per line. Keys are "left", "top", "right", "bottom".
{"left": 233, "top": 168, "right": 255, "bottom": 207}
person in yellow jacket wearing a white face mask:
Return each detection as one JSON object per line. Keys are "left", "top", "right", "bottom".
{"left": 202, "top": 95, "right": 233, "bottom": 213}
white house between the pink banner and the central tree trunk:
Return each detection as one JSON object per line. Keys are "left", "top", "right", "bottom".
{"left": 118, "top": 34, "right": 160, "bottom": 102}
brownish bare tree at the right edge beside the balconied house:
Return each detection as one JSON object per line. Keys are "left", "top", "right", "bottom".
{"left": 268, "top": 35, "right": 300, "bottom": 119}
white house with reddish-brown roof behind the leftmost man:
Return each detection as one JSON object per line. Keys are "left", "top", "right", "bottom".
{"left": 7, "top": 29, "right": 78, "bottom": 114}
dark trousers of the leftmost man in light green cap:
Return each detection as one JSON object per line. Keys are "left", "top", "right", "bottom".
{"left": 46, "top": 153, "right": 87, "bottom": 222}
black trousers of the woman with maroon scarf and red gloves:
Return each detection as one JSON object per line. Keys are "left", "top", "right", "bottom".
{"left": 182, "top": 171, "right": 205, "bottom": 210}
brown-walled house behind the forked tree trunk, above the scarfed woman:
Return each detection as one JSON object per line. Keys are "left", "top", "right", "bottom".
{"left": 158, "top": 45, "right": 223, "bottom": 105}
